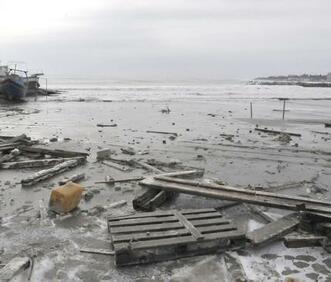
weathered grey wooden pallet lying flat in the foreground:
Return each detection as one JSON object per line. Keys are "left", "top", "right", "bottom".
{"left": 108, "top": 209, "right": 245, "bottom": 266}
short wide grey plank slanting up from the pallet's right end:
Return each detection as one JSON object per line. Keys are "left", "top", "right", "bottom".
{"left": 246, "top": 214, "right": 300, "bottom": 245}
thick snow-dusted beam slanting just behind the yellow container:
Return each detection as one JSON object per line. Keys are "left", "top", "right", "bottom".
{"left": 21, "top": 158, "right": 85, "bottom": 186}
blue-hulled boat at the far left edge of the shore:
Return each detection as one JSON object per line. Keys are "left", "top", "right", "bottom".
{"left": 0, "top": 69, "right": 27, "bottom": 101}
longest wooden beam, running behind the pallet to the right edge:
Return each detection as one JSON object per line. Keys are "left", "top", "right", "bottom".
{"left": 140, "top": 176, "right": 331, "bottom": 215}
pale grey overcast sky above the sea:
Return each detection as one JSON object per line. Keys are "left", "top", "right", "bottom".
{"left": 0, "top": 0, "right": 331, "bottom": 80}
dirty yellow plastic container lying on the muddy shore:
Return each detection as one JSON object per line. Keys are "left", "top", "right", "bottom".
{"left": 49, "top": 182, "right": 84, "bottom": 214}
